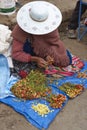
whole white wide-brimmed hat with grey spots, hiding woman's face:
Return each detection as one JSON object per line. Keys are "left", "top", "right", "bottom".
{"left": 17, "top": 1, "right": 62, "bottom": 35}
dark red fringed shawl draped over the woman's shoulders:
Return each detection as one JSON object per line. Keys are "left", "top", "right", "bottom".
{"left": 12, "top": 25, "right": 70, "bottom": 66}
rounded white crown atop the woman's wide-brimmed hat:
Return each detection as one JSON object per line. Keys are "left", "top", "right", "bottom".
{"left": 29, "top": 4, "right": 48, "bottom": 22}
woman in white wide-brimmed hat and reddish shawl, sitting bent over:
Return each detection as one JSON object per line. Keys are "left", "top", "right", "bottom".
{"left": 12, "top": 1, "right": 72, "bottom": 68}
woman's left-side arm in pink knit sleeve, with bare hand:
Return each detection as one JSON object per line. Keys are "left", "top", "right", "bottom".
{"left": 12, "top": 40, "right": 47, "bottom": 68}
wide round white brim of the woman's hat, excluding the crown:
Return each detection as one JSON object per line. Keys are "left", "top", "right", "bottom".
{"left": 17, "top": 1, "right": 62, "bottom": 35}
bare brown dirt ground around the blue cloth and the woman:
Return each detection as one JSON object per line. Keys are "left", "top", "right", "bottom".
{"left": 0, "top": 0, "right": 87, "bottom": 130}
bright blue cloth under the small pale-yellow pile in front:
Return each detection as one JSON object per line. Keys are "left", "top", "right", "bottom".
{"left": 0, "top": 88, "right": 68, "bottom": 129}
